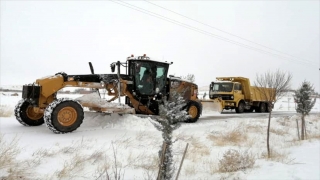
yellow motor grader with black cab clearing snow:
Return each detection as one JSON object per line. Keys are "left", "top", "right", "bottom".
{"left": 15, "top": 55, "right": 202, "bottom": 133}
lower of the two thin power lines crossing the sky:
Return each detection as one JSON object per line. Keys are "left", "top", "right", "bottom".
{"left": 111, "top": 0, "right": 314, "bottom": 64}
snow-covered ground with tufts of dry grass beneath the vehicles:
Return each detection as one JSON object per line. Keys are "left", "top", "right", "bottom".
{"left": 0, "top": 92, "right": 320, "bottom": 180}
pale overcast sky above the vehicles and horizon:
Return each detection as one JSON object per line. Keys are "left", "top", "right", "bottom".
{"left": 0, "top": 0, "right": 320, "bottom": 92}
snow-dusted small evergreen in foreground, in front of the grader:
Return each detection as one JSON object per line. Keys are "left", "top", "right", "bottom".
{"left": 151, "top": 92, "right": 189, "bottom": 180}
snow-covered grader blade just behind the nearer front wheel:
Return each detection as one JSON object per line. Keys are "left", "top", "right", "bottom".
{"left": 76, "top": 93, "right": 136, "bottom": 114}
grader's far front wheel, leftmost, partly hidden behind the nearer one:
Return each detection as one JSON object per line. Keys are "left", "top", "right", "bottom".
{"left": 14, "top": 99, "right": 44, "bottom": 126}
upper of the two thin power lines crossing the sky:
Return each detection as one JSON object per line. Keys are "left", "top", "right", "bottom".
{"left": 144, "top": 0, "right": 314, "bottom": 63}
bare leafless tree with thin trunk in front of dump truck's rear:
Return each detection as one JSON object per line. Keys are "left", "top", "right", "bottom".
{"left": 254, "top": 69, "right": 292, "bottom": 158}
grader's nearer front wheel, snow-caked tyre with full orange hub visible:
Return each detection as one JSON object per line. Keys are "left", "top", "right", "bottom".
{"left": 44, "top": 98, "right": 84, "bottom": 134}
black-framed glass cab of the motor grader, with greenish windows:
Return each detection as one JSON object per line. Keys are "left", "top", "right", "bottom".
{"left": 129, "top": 60, "right": 169, "bottom": 95}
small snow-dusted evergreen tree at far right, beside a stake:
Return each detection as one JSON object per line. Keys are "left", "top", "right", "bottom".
{"left": 293, "top": 80, "right": 316, "bottom": 140}
